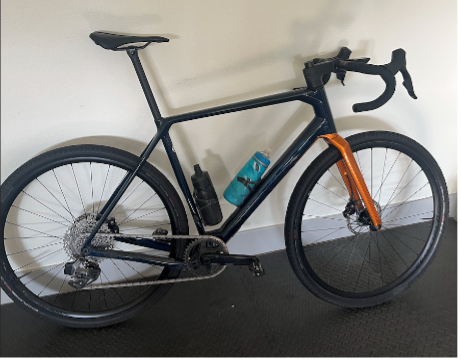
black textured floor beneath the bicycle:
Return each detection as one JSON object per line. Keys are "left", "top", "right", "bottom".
{"left": 1, "top": 220, "right": 458, "bottom": 357}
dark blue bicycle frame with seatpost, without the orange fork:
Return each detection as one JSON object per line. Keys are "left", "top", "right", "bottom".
{"left": 82, "top": 49, "right": 336, "bottom": 267}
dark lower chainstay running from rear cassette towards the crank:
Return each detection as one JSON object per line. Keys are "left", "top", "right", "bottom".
{"left": 85, "top": 246, "right": 186, "bottom": 270}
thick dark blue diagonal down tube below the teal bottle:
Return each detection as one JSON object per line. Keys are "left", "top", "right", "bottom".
{"left": 215, "top": 117, "right": 331, "bottom": 242}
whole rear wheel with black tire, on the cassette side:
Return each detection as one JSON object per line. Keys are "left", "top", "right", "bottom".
{"left": 0, "top": 145, "right": 188, "bottom": 327}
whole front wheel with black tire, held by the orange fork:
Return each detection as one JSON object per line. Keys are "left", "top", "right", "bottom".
{"left": 285, "top": 132, "right": 449, "bottom": 308}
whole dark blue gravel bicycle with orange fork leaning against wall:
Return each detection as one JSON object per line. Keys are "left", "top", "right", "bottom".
{"left": 0, "top": 32, "right": 449, "bottom": 327}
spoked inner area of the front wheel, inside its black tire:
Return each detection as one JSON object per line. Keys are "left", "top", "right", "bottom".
{"left": 298, "top": 144, "right": 438, "bottom": 299}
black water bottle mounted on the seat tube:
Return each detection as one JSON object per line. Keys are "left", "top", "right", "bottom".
{"left": 192, "top": 165, "right": 222, "bottom": 226}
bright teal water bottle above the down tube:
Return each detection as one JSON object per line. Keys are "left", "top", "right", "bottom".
{"left": 224, "top": 149, "right": 271, "bottom": 206}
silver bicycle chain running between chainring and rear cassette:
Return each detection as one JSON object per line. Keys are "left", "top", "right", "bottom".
{"left": 82, "top": 234, "right": 227, "bottom": 290}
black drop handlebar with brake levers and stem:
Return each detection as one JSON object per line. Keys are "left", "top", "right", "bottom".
{"left": 303, "top": 48, "right": 418, "bottom": 112}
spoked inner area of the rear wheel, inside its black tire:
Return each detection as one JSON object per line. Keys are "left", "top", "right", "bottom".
{"left": 1, "top": 160, "right": 175, "bottom": 318}
